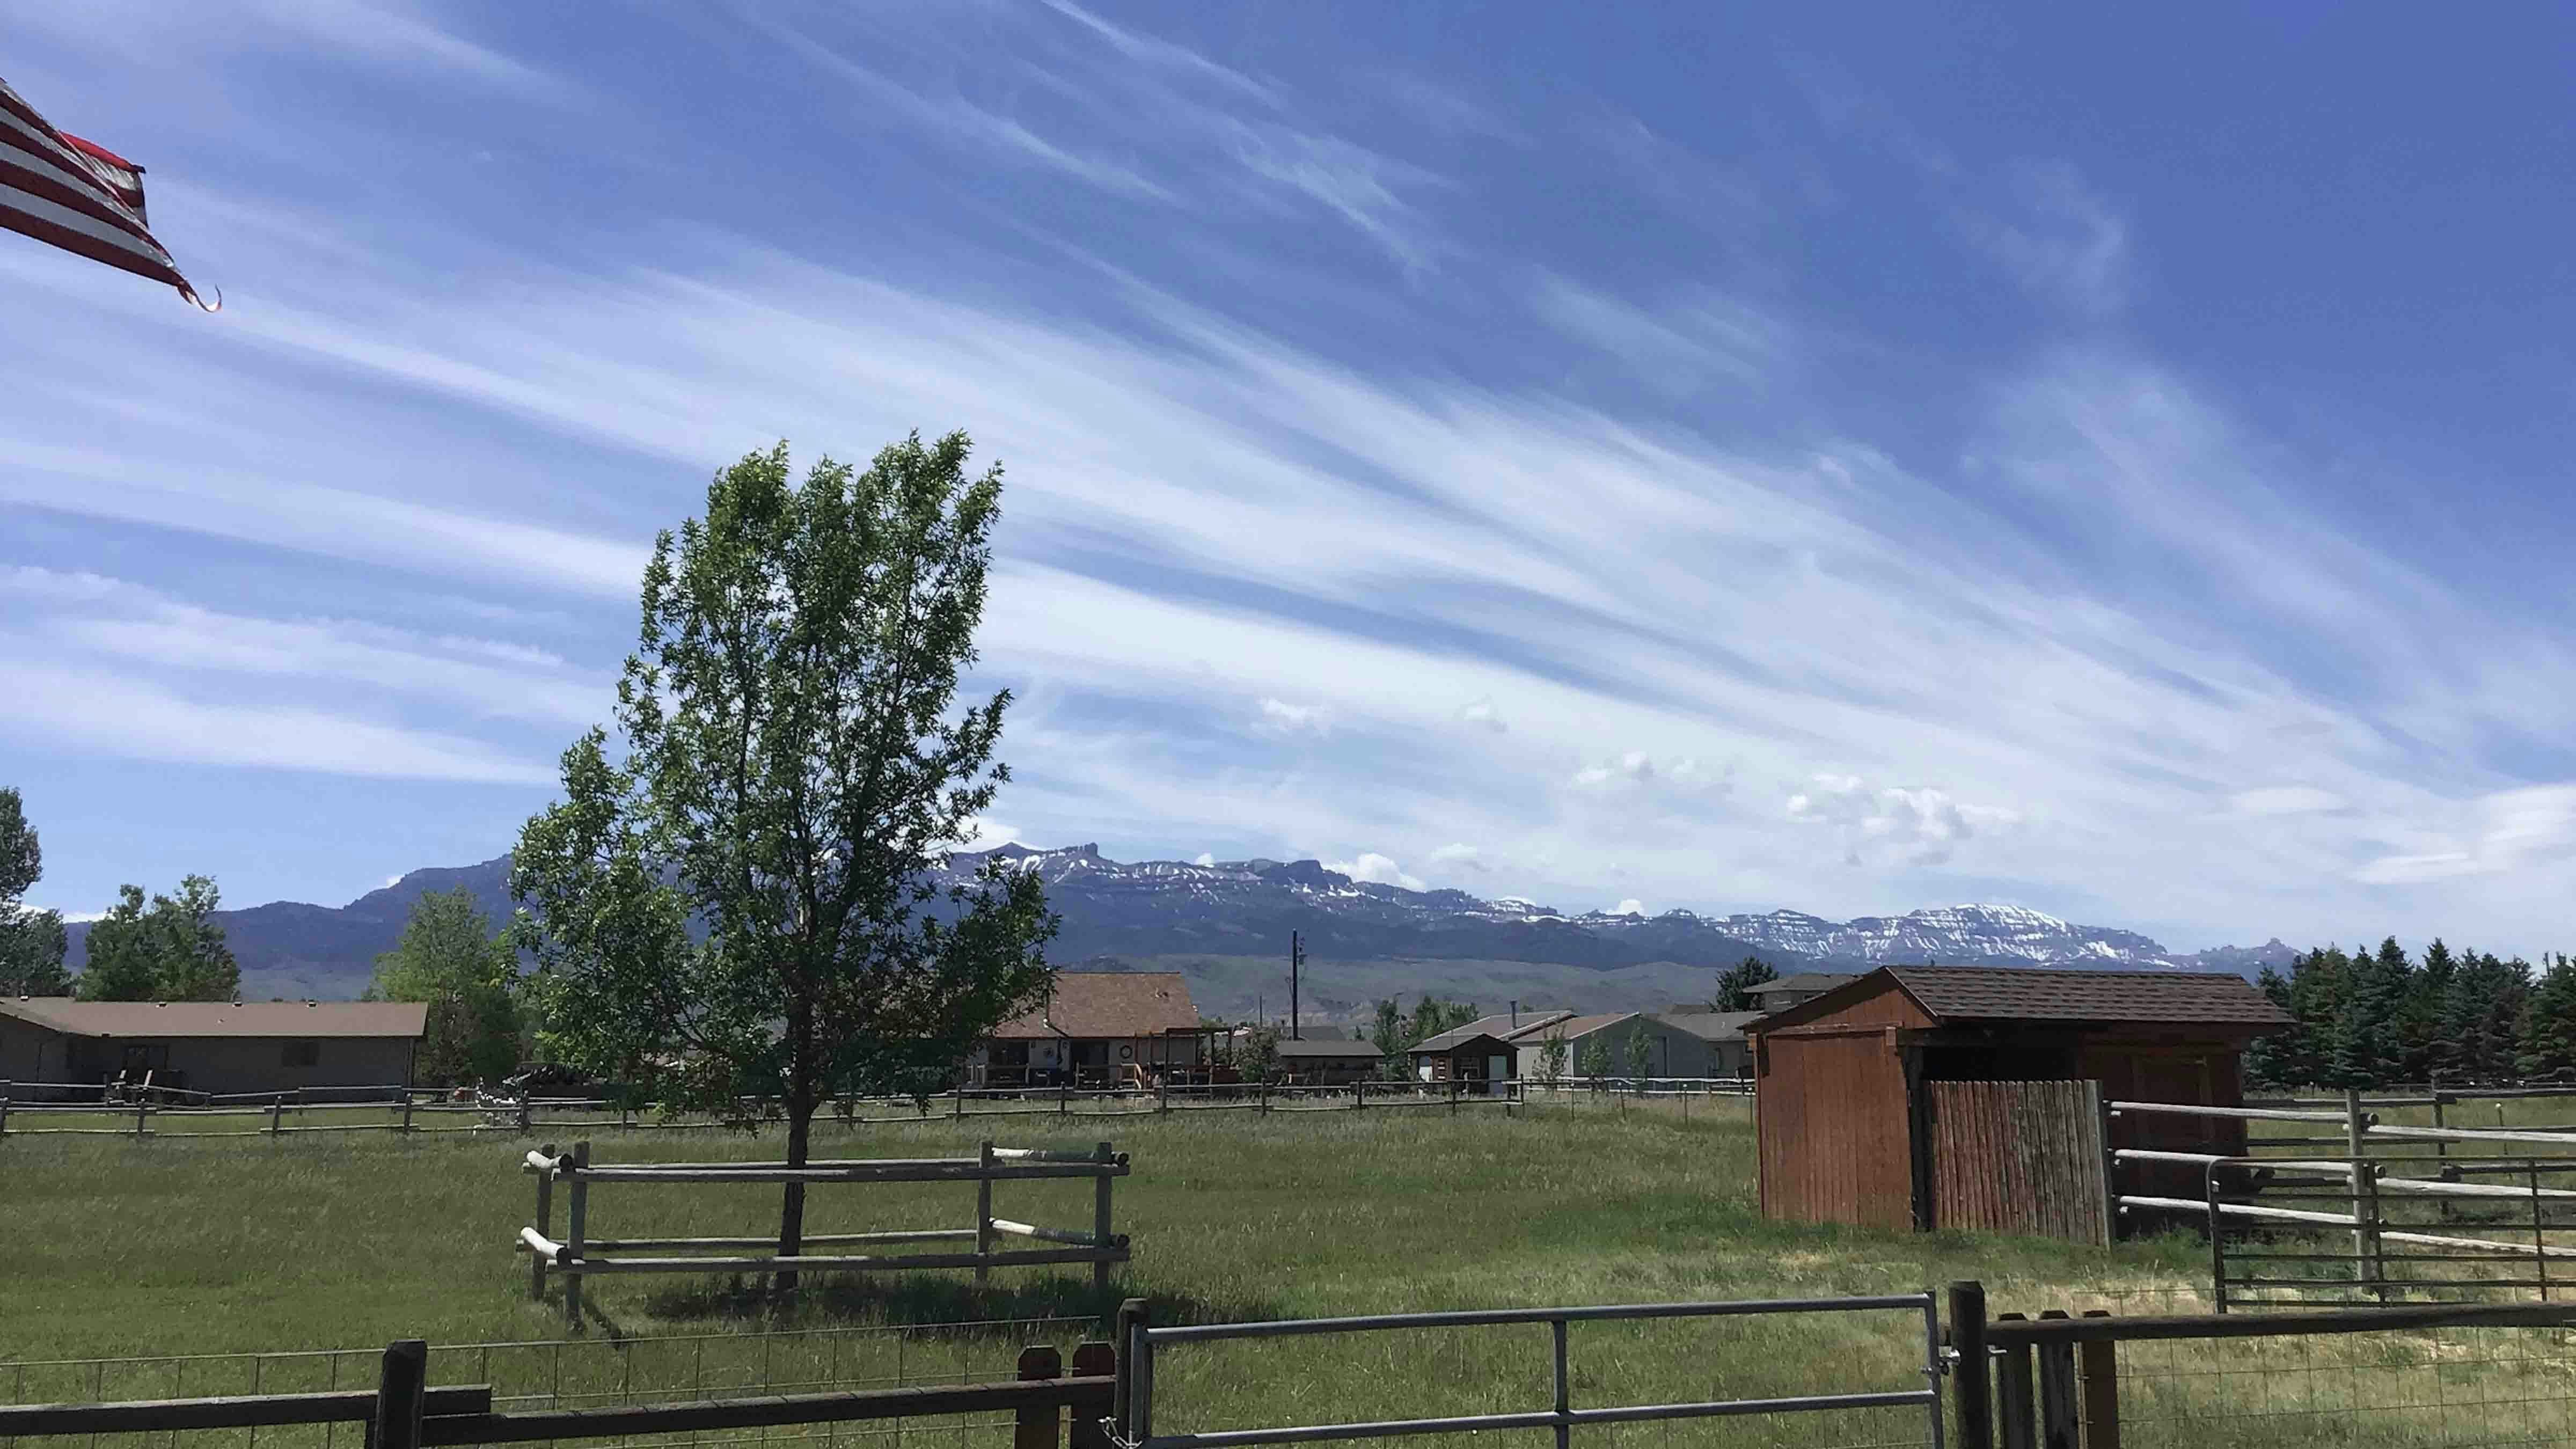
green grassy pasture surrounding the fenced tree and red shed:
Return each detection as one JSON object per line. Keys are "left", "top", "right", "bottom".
{"left": 0, "top": 1101, "right": 2576, "bottom": 1449}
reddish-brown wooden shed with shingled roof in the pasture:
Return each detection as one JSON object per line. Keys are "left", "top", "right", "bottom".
{"left": 1744, "top": 967, "right": 2287, "bottom": 1240}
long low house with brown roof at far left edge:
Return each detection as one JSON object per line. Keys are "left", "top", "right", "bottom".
{"left": 0, "top": 995, "right": 430, "bottom": 1099}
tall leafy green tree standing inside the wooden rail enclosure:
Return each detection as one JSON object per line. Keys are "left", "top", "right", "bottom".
{"left": 510, "top": 433, "right": 1056, "bottom": 1274}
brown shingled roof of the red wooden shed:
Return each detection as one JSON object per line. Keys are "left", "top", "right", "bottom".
{"left": 1754, "top": 967, "right": 2290, "bottom": 1031}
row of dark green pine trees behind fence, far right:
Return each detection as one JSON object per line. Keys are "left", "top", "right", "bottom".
{"left": 2246, "top": 936, "right": 2576, "bottom": 1088}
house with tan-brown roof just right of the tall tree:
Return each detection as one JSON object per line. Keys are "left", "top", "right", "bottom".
{"left": 966, "top": 972, "right": 1208, "bottom": 1088}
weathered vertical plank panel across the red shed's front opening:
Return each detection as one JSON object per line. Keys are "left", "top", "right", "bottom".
{"left": 1924, "top": 1083, "right": 2110, "bottom": 1243}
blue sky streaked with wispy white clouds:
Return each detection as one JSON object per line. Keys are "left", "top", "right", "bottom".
{"left": 0, "top": 0, "right": 2576, "bottom": 952}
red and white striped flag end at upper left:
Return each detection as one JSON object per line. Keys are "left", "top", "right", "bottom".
{"left": 0, "top": 80, "right": 211, "bottom": 312}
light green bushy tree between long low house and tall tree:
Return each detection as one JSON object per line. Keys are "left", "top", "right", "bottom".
{"left": 363, "top": 887, "right": 521, "bottom": 1086}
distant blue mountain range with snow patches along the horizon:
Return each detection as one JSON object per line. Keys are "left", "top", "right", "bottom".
{"left": 50, "top": 846, "right": 2293, "bottom": 1011}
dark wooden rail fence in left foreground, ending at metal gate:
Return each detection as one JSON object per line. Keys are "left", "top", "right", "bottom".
{"left": 0, "top": 1338, "right": 1118, "bottom": 1449}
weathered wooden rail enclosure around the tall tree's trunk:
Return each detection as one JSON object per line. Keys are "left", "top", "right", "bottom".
{"left": 518, "top": 1142, "right": 1128, "bottom": 1328}
